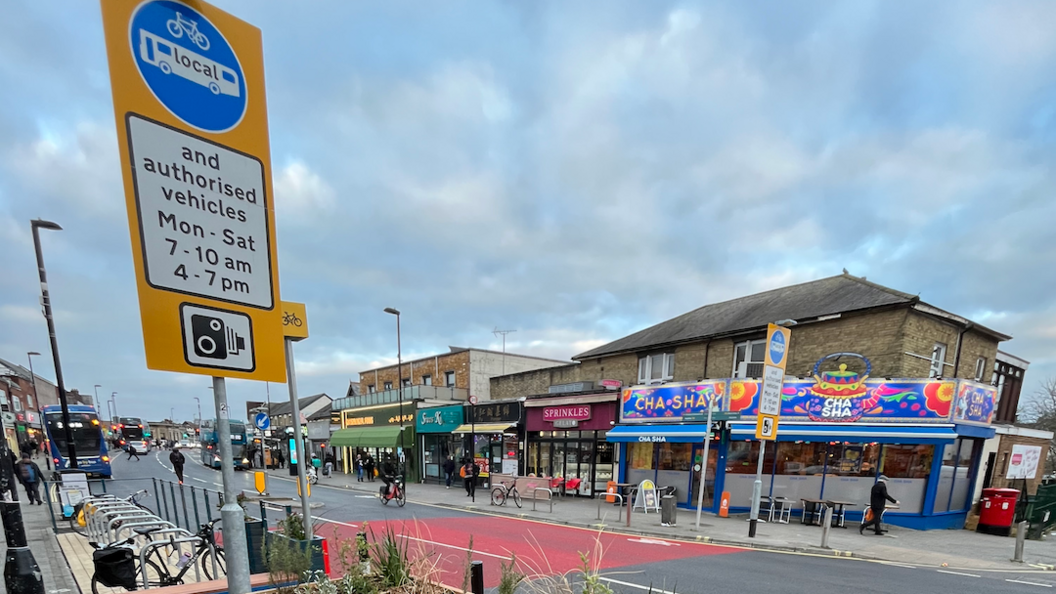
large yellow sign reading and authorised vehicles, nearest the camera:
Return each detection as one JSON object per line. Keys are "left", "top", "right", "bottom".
{"left": 101, "top": 0, "right": 286, "bottom": 382}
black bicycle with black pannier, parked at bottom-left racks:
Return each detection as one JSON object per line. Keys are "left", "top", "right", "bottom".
{"left": 89, "top": 519, "right": 227, "bottom": 594}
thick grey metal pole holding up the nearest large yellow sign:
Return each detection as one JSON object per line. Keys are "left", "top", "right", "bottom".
{"left": 211, "top": 377, "right": 252, "bottom": 594}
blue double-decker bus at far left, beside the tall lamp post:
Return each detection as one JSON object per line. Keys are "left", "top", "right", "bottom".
{"left": 41, "top": 405, "right": 111, "bottom": 479}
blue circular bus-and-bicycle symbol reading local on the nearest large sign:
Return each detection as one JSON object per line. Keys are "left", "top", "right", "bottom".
{"left": 129, "top": 0, "right": 247, "bottom": 132}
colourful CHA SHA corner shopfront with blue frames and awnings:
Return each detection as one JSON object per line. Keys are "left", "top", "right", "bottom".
{"left": 606, "top": 353, "right": 997, "bottom": 530}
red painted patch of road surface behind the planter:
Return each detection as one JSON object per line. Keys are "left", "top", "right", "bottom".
{"left": 319, "top": 516, "right": 743, "bottom": 588}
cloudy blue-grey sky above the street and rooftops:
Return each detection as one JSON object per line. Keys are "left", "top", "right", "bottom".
{"left": 0, "top": 0, "right": 1056, "bottom": 420}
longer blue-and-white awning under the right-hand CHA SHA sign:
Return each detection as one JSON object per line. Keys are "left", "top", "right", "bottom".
{"left": 730, "top": 423, "right": 957, "bottom": 445}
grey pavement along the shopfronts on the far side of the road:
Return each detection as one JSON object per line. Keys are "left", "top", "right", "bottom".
{"left": 280, "top": 470, "right": 1056, "bottom": 570}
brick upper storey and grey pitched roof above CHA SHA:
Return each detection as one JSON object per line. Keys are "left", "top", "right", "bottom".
{"left": 492, "top": 274, "right": 1011, "bottom": 398}
